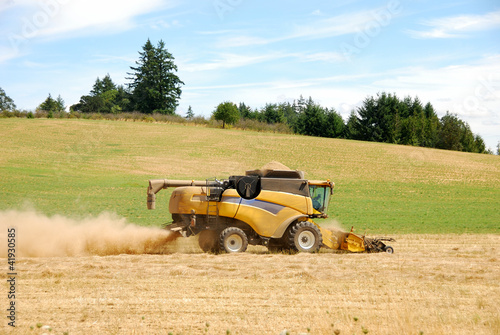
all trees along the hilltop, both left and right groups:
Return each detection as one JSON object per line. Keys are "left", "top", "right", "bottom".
{"left": 0, "top": 39, "right": 500, "bottom": 154}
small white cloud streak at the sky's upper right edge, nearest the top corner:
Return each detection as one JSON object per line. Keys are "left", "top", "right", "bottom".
{"left": 407, "top": 11, "right": 500, "bottom": 39}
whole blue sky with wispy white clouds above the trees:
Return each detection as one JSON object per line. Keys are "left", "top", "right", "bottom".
{"left": 0, "top": 0, "right": 500, "bottom": 150}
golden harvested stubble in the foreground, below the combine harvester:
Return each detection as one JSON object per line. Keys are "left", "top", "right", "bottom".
{"left": 1, "top": 235, "right": 500, "bottom": 334}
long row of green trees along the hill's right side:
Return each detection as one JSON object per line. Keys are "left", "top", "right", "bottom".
{"left": 213, "top": 92, "right": 489, "bottom": 153}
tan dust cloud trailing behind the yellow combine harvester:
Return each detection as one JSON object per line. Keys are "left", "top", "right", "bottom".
{"left": 0, "top": 210, "right": 177, "bottom": 257}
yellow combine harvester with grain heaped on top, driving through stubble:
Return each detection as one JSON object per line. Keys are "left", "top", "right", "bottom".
{"left": 148, "top": 169, "right": 393, "bottom": 253}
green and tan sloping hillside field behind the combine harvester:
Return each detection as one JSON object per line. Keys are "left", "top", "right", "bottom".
{"left": 0, "top": 119, "right": 500, "bottom": 235}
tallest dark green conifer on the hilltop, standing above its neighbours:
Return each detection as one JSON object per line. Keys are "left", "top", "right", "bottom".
{"left": 128, "top": 39, "right": 184, "bottom": 114}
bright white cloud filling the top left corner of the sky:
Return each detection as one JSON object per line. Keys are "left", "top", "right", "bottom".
{"left": 0, "top": 0, "right": 179, "bottom": 64}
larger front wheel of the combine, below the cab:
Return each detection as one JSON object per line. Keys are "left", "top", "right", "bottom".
{"left": 288, "top": 221, "right": 323, "bottom": 252}
